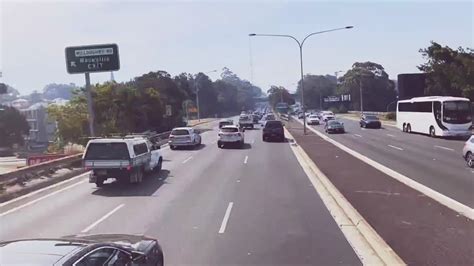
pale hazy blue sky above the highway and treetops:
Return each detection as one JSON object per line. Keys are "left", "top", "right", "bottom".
{"left": 0, "top": 0, "right": 474, "bottom": 94}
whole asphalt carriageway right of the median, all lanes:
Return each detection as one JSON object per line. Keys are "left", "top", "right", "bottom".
{"left": 312, "top": 117, "right": 474, "bottom": 208}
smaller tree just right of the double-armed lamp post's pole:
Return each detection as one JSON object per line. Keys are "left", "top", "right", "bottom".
{"left": 296, "top": 75, "right": 336, "bottom": 109}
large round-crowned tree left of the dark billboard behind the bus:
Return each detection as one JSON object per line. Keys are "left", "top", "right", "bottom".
{"left": 336, "top": 62, "right": 396, "bottom": 111}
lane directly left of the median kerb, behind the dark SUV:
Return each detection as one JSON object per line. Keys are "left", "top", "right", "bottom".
{"left": 212, "top": 127, "right": 361, "bottom": 265}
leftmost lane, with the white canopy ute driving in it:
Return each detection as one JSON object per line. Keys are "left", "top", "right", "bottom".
{"left": 0, "top": 125, "right": 222, "bottom": 240}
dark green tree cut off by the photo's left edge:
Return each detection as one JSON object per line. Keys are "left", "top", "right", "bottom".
{"left": 0, "top": 105, "right": 30, "bottom": 147}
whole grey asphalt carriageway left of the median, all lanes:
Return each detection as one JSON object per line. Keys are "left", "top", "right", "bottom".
{"left": 0, "top": 119, "right": 360, "bottom": 265}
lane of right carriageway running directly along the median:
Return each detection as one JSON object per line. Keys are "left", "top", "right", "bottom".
{"left": 308, "top": 119, "right": 474, "bottom": 207}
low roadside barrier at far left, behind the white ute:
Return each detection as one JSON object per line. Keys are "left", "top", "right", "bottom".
{"left": 0, "top": 153, "right": 82, "bottom": 186}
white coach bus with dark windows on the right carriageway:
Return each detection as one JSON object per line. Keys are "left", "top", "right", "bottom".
{"left": 397, "top": 96, "right": 472, "bottom": 137}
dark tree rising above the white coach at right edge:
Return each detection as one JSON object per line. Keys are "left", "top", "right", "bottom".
{"left": 418, "top": 41, "right": 474, "bottom": 101}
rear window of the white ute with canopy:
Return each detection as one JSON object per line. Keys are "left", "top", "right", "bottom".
{"left": 84, "top": 142, "right": 130, "bottom": 160}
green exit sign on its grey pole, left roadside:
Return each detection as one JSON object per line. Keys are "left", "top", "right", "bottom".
{"left": 65, "top": 44, "right": 120, "bottom": 137}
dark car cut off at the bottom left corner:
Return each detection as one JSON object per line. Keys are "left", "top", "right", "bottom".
{"left": 0, "top": 235, "right": 163, "bottom": 266}
